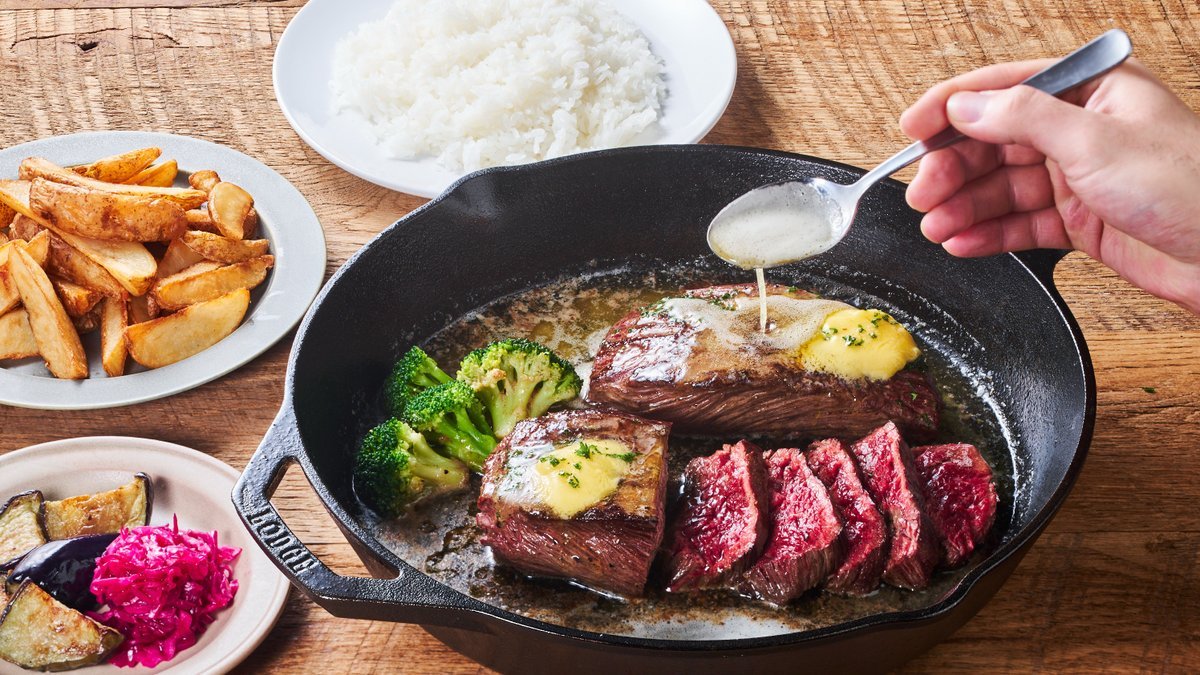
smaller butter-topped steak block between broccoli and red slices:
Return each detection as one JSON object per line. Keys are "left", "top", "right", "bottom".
{"left": 476, "top": 410, "right": 671, "bottom": 597}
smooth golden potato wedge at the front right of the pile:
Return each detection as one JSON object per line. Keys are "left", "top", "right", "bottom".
{"left": 125, "top": 288, "right": 250, "bottom": 368}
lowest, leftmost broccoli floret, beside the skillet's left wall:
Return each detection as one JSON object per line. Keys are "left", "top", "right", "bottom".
{"left": 354, "top": 417, "right": 468, "bottom": 518}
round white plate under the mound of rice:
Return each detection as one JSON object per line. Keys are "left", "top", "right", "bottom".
{"left": 275, "top": 0, "right": 737, "bottom": 197}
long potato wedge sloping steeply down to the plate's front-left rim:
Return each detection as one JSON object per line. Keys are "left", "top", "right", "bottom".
{"left": 8, "top": 246, "right": 88, "bottom": 380}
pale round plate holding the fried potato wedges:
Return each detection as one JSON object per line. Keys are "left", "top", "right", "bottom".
{"left": 0, "top": 131, "right": 325, "bottom": 410}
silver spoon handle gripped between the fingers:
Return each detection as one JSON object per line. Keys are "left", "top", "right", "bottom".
{"left": 858, "top": 28, "right": 1133, "bottom": 191}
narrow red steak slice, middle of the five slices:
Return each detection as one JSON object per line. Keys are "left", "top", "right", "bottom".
{"left": 805, "top": 438, "right": 888, "bottom": 596}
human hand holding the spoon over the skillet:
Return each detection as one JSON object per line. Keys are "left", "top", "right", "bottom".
{"left": 900, "top": 60, "right": 1200, "bottom": 313}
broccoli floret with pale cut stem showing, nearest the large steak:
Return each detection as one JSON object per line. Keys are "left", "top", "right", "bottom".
{"left": 458, "top": 338, "right": 583, "bottom": 438}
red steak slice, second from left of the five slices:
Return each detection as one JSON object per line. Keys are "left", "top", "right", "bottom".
{"left": 738, "top": 448, "right": 842, "bottom": 604}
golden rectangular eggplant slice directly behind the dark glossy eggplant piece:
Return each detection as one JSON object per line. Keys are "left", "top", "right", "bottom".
{"left": 44, "top": 473, "right": 154, "bottom": 539}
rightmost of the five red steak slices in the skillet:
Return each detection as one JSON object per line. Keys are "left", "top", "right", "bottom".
{"left": 912, "top": 443, "right": 996, "bottom": 567}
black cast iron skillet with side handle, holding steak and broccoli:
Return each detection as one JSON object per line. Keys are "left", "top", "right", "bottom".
{"left": 233, "top": 145, "right": 1096, "bottom": 674}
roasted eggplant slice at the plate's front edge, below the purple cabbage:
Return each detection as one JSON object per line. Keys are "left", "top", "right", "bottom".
{"left": 0, "top": 581, "right": 125, "bottom": 670}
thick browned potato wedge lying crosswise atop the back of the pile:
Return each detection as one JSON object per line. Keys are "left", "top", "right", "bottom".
{"left": 29, "top": 178, "right": 187, "bottom": 241}
